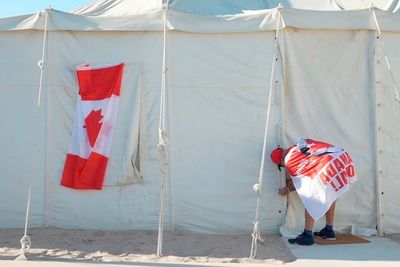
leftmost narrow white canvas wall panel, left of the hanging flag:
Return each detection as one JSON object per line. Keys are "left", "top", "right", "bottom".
{"left": 0, "top": 31, "right": 46, "bottom": 227}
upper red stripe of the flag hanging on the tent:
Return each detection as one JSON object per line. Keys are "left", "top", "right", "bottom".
{"left": 76, "top": 63, "right": 124, "bottom": 100}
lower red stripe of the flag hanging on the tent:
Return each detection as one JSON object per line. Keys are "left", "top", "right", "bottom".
{"left": 61, "top": 152, "right": 108, "bottom": 190}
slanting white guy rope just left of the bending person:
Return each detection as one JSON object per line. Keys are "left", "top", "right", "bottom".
{"left": 249, "top": 4, "right": 283, "bottom": 259}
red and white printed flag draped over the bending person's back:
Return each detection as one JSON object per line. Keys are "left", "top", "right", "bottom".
{"left": 285, "top": 138, "right": 357, "bottom": 220}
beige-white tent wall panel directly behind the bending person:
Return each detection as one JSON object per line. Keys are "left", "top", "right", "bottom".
{"left": 281, "top": 27, "right": 376, "bottom": 237}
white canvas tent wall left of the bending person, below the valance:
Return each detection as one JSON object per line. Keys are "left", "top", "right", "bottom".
{"left": 1, "top": 31, "right": 285, "bottom": 233}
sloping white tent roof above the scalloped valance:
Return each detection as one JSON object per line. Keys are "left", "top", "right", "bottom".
{"left": 71, "top": 0, "right": 400, "bottom": 16}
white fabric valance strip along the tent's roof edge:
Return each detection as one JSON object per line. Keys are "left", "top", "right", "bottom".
{"left": 0, "top": 7, "right": 400, "bottom": 33}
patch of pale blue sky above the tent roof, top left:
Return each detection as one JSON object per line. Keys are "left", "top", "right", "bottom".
{"left": 0, "top": 0, "right": 94, "bottom": 18}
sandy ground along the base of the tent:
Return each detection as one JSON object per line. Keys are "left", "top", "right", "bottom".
{"left": 0, "top": 228, "right": 296, "bottom": 264}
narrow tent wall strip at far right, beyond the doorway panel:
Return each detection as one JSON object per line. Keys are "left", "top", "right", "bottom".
{"left": 373, "top": 33, "right": 400, "bottom": 233}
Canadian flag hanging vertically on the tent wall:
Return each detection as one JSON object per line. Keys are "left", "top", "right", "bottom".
{"left": 61, "top": 63, "right": 124, "bottom": 190}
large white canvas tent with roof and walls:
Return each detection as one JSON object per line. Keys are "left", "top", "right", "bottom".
{"left": 0, "top": 0, "right": 400, "bottom": 245}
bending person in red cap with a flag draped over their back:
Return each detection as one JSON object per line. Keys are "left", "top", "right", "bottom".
{"left": 271, "top": 138, "right": 356, "bottom": 246}
